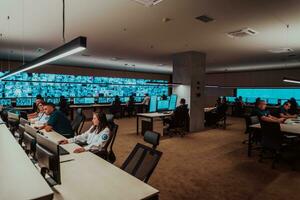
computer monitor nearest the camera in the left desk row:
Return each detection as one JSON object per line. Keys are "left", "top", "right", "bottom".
{"left": 35, "top": 134, "right": 61, "bottom": 186}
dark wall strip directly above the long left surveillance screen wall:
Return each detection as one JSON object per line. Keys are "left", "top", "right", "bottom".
{"left": 0, "top": 61, "right": 171, "bottom": 81}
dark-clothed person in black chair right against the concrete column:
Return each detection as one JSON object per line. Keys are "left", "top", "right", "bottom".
{"left": 164, "top": 98, "right": 189, "bottom": 131}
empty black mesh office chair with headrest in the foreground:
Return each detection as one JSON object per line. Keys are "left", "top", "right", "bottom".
{"left": 121, "top": 131, "right": 162, "bottom": 183}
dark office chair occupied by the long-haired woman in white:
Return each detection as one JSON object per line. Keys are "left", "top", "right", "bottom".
{"left": 92, "top": 123, "right": 119, "bottom": 163}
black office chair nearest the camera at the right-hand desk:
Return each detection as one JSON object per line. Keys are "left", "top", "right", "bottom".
{"left": 259, "top": 121, "right": 294, "bottom": 169}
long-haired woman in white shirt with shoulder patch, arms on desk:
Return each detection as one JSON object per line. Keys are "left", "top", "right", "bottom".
{"left": 59, "top": 112, "right": 110, "bottom": 153}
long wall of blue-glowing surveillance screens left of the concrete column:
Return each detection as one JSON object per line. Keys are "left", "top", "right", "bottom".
{"left": 0, "top": 72, "right": 168, "bottom": 98}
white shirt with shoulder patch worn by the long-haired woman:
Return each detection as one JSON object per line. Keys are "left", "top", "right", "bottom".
{"left": 68, "top": 126, "right": 110, "bottom": 151}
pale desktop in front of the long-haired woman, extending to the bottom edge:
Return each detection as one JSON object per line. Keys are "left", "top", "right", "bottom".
{"left": 38, "top": 127, "right": 159, "bottom": 200}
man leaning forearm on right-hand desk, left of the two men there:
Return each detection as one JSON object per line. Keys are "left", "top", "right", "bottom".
{"left": 253, "top": 100, "right": 286, "bottom": 123}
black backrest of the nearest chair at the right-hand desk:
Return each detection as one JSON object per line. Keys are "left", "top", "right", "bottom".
{"left": 260, "top": 121, "right": 284, "bottom": 150}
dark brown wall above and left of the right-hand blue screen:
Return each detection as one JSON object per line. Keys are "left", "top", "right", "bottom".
{"left": 205, "top": 69, "right": 300, "bottom": 106}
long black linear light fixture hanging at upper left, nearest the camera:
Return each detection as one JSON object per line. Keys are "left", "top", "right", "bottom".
{"left": 0, "top": 36, "right": 86, "bottom": 80}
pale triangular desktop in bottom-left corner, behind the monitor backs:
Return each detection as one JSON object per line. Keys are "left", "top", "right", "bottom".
{"left": 0, "top": 124, "right": 53, "bottom": 200}
